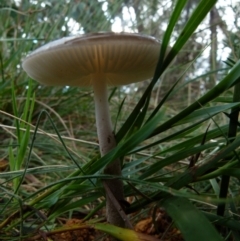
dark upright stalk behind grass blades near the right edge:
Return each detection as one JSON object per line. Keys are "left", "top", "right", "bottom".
{"left": 217, "top": 81, "right": 240, "bottom": 216}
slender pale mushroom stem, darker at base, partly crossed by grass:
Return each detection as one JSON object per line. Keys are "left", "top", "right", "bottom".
{"left": 92, "top": 75, "right": 125, "bottom": 227}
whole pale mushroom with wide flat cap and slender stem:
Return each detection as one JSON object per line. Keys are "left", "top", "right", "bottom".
{"left": 22, "top": 33, "right": 160, "bottom": 227}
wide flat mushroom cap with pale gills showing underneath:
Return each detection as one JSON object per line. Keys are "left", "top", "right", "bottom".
{"left": 22, "top": 33, "right": 160, "bottom": 86}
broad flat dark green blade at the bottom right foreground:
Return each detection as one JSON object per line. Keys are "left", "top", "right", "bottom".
{"left": 160, "top": 196, "right": 223, "bottom": 241}
